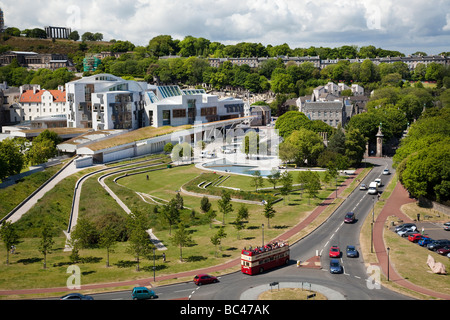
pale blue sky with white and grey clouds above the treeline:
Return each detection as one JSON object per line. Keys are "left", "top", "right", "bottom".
{"left": 0, "top": 0, "right": 450, "bottom": 55}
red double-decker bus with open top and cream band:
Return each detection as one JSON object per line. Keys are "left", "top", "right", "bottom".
{"left": 241, "top": 241, "right": 289, "bottom": 275}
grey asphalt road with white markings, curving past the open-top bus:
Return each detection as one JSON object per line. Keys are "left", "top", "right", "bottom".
{"left": 88, "top": 158, "right": 410, "bottom": 300}
